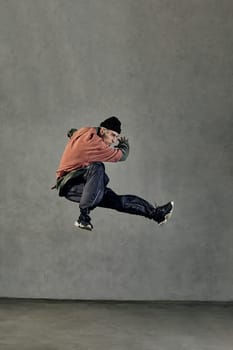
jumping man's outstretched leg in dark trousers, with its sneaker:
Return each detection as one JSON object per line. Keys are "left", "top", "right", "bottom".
{"left": 98, "top": 188, "right": 174, "bottom": 224}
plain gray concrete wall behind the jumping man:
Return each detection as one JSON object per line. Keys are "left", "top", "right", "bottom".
{"left": 0, "top": 0, "right": 233, "bottom": 300}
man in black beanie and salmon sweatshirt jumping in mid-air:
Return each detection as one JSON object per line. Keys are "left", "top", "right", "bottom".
{"left": 53, "top": 117, "right": 174, "bottom": 230}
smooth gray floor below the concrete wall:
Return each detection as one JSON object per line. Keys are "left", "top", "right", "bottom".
{"left": 0, "top": 299, "right": 233, "bottom": 350}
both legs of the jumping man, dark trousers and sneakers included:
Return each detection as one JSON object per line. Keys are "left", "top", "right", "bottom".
{"left": 62, "top": 162, "right": 174, "bottom": 230}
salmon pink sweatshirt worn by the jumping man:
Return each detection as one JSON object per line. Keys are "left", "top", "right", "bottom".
{"left": 56, "top": 127, "right": 123, "bottom": 178}
